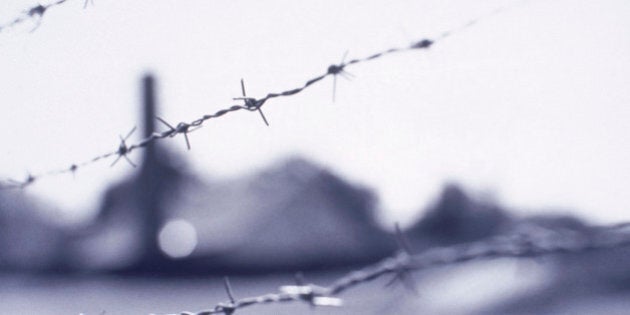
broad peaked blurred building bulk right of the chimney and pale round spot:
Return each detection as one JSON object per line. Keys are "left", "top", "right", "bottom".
{"left": 169, "top": 158, "right": 394, "bottom": 270}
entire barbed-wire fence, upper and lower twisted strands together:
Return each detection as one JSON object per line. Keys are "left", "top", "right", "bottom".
{"left": 0, "top": 0, "right": 630, "bottom": 315}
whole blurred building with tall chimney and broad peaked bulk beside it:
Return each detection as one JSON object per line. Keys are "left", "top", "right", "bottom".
{"left": 64, "top": 77, "right": 393, "bottom": 273}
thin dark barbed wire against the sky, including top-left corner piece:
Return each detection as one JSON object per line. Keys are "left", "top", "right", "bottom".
{"left": 0, "top": 0, "right": 529, "bottom": 189}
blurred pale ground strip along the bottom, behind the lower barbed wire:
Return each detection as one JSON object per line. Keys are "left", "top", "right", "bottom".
{"left": 0, "top": 259, "right": 630, "bottom": 315}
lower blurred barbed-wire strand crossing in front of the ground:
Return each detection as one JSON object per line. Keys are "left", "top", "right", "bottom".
{"left": 162, "top": 222, "right": 630, "bottom": 315}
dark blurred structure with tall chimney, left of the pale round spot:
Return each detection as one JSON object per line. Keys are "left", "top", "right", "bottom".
{"left": 75, "top": 75, "right": 185, "bottom": 272}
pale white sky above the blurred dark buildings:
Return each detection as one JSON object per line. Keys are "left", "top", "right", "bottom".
{"left": 0, "top": 0, "right": 630, "bottom": 227}
